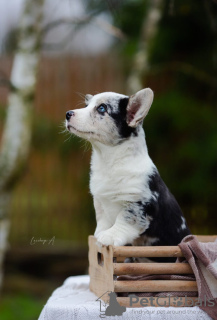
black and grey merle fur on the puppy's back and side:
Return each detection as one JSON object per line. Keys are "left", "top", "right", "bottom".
{"left": 122, "top": 170, "right": 191, "bottom": 262}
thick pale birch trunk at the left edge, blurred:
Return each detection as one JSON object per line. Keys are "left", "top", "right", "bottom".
{"left": 0, "top": 0, "right": 44, "bottom": 287}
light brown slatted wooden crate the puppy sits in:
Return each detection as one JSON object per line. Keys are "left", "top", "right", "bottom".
{"left": 88, "top": 236, "right": 217, "bottom": 307}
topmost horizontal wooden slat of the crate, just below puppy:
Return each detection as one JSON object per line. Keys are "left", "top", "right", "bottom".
{"left": 113, "top": 246, "right": 183, "bottom": 258}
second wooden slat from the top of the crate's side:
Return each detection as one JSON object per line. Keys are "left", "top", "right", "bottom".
{"left": 113, "top": 263, "right": 193, "bottom": 275}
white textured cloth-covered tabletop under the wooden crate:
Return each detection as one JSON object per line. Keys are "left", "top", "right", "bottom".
{"left": 38, "top": 275, "right": 212, "bottom": 320}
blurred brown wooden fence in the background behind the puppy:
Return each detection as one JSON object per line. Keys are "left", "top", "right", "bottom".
{"left": 0, "top": 54, "right": 125, "bottom": 245}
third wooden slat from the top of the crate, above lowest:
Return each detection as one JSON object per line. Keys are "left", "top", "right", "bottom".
{"left": 114, "top": 280, "right": 197, "bottom": 292}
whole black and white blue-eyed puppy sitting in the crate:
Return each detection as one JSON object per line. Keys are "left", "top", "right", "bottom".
{"left": 66, "top": 88, "right": 190, "bottom": 246}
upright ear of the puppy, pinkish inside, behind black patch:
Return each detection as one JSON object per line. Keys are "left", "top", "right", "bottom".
{"left": 127, "top": 88, "right": 154, "bottom": 128}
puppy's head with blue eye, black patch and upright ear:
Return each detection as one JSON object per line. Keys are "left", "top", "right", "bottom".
{"left": 66, "top": 88, "right": 154, "bottom": 145}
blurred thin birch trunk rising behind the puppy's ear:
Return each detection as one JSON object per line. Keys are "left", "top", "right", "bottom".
{"left": 127, "top": 0, "right": 164, "bottom": 94}
